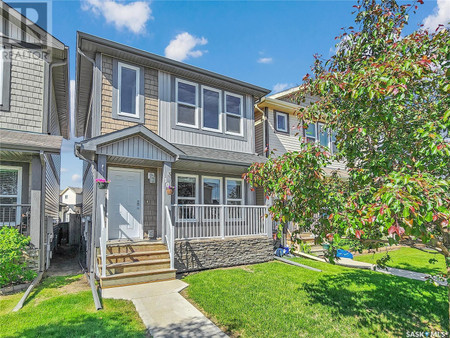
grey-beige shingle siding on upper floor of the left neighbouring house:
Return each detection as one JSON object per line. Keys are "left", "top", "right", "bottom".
{"left": 0, "top": 48, "right": 44, "bottom": 133}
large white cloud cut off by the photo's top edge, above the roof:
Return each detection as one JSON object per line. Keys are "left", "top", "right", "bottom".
{"left": 81, "top": 0, "right": 153, "bottom": 34}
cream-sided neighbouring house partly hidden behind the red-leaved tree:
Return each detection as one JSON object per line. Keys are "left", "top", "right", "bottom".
{"left": 255, "top": 87, "right": 347, "bottom": 177}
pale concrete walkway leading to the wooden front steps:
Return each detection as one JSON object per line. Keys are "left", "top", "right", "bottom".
{"left": 102, "top": 280, "right": 227, "bottom": 337}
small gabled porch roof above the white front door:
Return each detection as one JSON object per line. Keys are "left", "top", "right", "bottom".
{"left": 75, "top": 125, "right": 182, "bottom": 162}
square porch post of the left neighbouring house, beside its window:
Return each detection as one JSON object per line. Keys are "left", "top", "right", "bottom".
{"left": 30, "top": 156, "right": 44, "bottom": 249}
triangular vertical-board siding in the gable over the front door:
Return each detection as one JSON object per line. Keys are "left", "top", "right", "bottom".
{"left": 97, "top": 136, "right": 173, "bottom": 162}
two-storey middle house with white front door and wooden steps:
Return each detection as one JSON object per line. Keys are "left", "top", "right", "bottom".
{"left": 75, "top": 32, "right": 272, "bottom": 287}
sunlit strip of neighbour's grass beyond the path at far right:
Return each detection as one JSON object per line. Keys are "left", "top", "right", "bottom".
{"left": 354, "top": 248, "right": 446, "bottom": 274}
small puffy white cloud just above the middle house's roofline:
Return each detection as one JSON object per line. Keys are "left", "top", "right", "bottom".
{"left": 164, "top": 32, "right": 208, "bottom": 61}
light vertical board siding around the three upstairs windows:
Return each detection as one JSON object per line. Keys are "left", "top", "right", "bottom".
{"left": 158, "top": 71, "right": 255, "bottom": 154}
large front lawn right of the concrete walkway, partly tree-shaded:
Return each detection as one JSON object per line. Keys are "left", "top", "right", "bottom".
{"left": 185, "top": 258, "right": 448, "bottom": 337}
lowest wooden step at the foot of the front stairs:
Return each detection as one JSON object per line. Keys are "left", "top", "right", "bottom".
{"left": 100, "top": 269, "right": 176, "bottom": 289}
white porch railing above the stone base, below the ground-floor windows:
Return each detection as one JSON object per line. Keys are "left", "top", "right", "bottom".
{"left": 173, "top": 204, "right": 272, "bottom": 239}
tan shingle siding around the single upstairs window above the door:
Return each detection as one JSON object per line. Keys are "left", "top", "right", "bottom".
{"left": 100, "top": 55, "right": 158, "bottom": 135}
